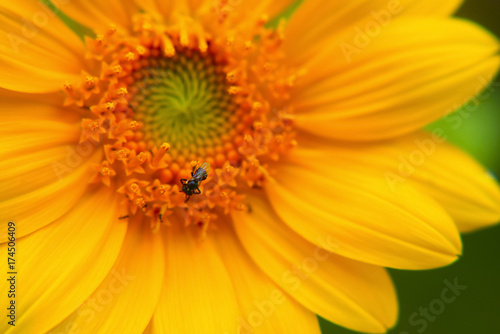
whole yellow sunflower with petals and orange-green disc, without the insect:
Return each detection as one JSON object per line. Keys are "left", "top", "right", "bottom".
{"left": 0, "top": 0, "right": 500, "bottom": 334}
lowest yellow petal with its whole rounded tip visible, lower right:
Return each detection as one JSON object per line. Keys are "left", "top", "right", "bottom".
{"left": 233, "top": 195, "right": 398, "bottom": 333}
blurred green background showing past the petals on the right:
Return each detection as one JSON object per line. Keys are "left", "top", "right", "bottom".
{"left": 320, "top": 0, "right": 500, "bottom": 334}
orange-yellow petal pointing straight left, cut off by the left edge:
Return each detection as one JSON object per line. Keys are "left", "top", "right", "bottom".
{"left": 0, "top": 102, "right": 80, "bottom": 200}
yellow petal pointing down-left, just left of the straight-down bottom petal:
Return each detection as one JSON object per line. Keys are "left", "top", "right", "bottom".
{"left": 48, "top": 215, "right": 165, "bottom": 334}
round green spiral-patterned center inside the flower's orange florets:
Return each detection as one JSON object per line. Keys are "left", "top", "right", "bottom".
{"left": 130, "top": 51, "right": 236, "bottom": 153}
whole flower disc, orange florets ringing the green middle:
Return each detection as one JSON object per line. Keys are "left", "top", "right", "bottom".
{"left": 63, "top": 11, "right": 300, "bottom": 233}
